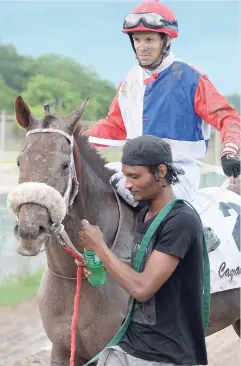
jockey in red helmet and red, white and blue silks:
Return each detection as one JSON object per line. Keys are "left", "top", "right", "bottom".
{"left": 85, "top": 0, "right": 240, "bottom": 201}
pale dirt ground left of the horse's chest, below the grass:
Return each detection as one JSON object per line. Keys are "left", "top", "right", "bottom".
{"left": 0, "top": 299, "right": 50, "bottom": 366}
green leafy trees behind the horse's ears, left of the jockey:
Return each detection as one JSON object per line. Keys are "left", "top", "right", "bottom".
{"left": 0, "top": 44, "right": 115, "bottom": 121}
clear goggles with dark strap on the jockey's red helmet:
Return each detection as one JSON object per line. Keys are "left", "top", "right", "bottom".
{"left": 123, "top": 13, "right": 178, "bottom": 29}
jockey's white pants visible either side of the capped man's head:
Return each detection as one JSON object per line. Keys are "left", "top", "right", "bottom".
{"left": 106, "top": 160, "right": 200, "bottom": 202}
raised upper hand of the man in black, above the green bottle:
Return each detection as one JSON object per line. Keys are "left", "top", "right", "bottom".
{"left": 79, "top": 220, "right": 106, "bottom": 252}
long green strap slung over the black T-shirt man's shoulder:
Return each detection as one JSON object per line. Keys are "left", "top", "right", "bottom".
{"left": 84, "top": 199, "right": 210, "bottom": 366}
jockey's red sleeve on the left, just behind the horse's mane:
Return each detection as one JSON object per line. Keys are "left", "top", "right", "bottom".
{"left": 84, "top": 86, "right": 126, "bottom": 146}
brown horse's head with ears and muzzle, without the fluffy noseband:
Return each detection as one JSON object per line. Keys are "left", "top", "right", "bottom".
{"left": 10, "top": 97, "right": 86, "bottom": 255}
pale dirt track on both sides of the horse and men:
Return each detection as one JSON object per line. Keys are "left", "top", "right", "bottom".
{"left": 0, "top": 299, "right": 241, "bottom": 366}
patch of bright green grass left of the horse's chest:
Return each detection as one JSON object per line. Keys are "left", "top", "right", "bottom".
{"left": 0, "top": 268, "right": 44, "bottom": 307}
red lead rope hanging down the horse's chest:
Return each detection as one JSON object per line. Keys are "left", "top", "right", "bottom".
{"left": 64, "top": 247, "right": 82, "bottom": 366}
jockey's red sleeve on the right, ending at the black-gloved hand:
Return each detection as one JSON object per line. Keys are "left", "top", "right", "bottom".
{"left": 194, "top": 75, "right": 241, "bottom": 153}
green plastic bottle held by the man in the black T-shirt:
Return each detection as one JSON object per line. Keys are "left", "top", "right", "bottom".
{"left": 84, "top": 249, "right": 106, "bottom": 286}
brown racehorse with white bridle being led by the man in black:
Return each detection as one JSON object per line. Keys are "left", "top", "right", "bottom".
{"left": 6, "top": 96, "right": 240, "bottom": 366}
